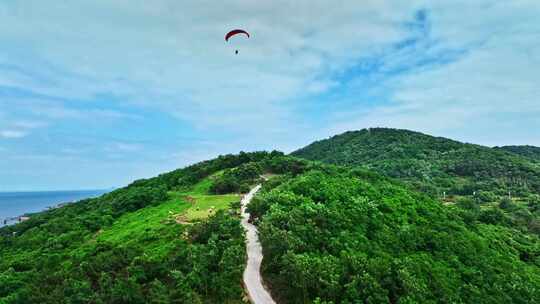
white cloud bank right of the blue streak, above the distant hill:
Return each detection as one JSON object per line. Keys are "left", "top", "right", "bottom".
{"left": 326, "top": 1, "right": 540, "bottom": 145}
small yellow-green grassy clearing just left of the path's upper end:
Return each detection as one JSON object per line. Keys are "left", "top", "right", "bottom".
{"left": 186, "top": 194, "right": 240, "bottom": 221}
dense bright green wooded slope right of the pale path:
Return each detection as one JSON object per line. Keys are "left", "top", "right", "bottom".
{"left": 249, "top": 166, "right": 540, "bottom": 303}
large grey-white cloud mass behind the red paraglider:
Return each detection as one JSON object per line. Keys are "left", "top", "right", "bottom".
{"left": 0, "top": 1, "right": 420, "bottom": 132}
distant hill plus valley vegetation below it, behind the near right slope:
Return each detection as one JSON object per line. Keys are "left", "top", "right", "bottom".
{"left": 292, "top": 128, "right": 540, "bottom": 233}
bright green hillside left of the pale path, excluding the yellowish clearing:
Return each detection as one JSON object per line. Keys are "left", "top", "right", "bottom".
{"left": 0, "top": 152, "right": 304, "bottom": 303}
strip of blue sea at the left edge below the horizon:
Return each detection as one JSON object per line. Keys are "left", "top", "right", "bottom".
{"left": 0, "top": 190, "right": 110, "bottom": 227}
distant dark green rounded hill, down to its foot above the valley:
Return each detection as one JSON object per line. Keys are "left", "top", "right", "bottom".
{"left": 291, "top": 128, "right": 540, "bottom": 195}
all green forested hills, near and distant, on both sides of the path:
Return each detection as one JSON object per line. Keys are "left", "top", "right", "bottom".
{"left": 0, "top": 129, "right": 540, "bottom": 304}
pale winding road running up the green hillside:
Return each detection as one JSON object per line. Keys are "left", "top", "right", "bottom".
{"left": 242, "top": 185, "right": 276, "bottom": 304}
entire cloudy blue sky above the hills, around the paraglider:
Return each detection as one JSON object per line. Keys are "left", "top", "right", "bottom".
{"left": 0, "top": 0, "right": 540, "bottom": 191}
